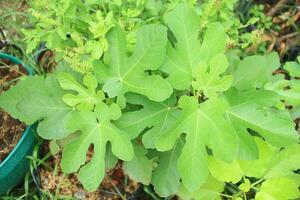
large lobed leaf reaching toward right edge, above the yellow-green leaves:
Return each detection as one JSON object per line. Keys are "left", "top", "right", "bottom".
{"left": 226, "top": 90, "right": 298, "bottom": 159}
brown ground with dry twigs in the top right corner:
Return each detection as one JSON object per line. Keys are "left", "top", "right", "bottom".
{"left": 246, "top": 0, "right": 300, "bottom": 62}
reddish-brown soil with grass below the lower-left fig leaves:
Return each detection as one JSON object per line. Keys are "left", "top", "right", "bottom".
{"left": 38, "top": 145, "right": 152, "bottom": 200}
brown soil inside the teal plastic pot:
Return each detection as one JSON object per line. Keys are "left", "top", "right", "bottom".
{"left": 0, "top": 60, "right": 27, "bottom": 163}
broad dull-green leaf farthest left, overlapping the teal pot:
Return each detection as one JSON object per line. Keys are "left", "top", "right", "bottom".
{"left": 0, "top": 75, "right": 74, "bottom": 139}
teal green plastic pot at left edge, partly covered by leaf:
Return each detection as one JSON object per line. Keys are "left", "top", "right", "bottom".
{"left": 0, "top": 53, "right": 37, "bottom": 196}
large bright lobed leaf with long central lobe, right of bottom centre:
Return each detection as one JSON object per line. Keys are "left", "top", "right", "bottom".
{"left": 156, "top": 96, "right": 237, "bottom": 191}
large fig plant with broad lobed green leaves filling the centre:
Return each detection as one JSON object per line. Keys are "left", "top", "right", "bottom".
{"left": 0, "top": 1, "right": 300, "bottom": 200}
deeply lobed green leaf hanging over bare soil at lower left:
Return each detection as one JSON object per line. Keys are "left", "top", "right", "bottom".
{"left": 61, "top": 102, "right": 133, "bottom": 191}
